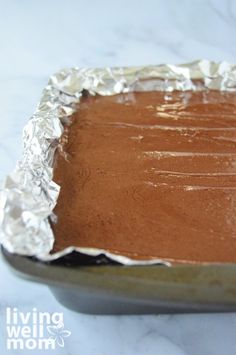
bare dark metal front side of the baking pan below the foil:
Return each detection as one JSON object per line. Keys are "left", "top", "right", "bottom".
{"left": 2, "top": 248, "right": 236, "bottom": 314}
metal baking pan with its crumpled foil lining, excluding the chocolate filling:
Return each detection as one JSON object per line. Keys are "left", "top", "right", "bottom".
{"left": 0, "top": 61, "right": 236, "bottom": 314}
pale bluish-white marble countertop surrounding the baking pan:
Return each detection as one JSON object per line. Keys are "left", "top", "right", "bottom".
{"left": 0, "top": 0, "right": 236, "bottom": 355}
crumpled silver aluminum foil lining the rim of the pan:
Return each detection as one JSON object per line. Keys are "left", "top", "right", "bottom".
{"left": 0, "top": 60, "right": 236, "bottom": 265}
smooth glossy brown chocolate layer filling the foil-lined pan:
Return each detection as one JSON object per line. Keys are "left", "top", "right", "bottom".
{"left": 53, "top": 91, "right": 236, "bottom": 263}
